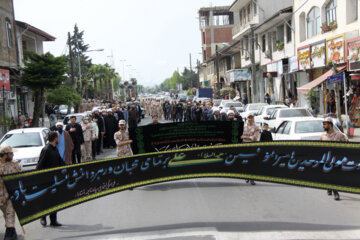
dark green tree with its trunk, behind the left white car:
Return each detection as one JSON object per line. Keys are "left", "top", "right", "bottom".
{"left": 21, "top": 51, "right": 67, "bottom": 127}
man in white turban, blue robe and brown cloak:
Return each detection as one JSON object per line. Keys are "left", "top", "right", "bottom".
{"left": 56, "top": 122, "right": 74, "bottom": 165}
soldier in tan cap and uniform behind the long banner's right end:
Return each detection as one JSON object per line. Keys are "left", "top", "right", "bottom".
{"left": 320, "top": 117, "right": 348, "bottom": 201}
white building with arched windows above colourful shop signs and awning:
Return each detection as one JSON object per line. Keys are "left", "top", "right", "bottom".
{"left": 294, "top": 0, "right": 360, "bottom": 114}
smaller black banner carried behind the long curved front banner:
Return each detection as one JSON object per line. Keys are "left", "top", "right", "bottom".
{"left": 129, "top": 121, "right": 244, "bottom": 154}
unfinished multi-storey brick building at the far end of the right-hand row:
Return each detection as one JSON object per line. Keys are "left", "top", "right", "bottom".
{"left": 199, "top": 6, "right": 234, "bottom": 87}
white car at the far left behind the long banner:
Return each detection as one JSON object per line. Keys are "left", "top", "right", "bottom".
{"left": 0, "top": 128, "right": 50, "bottom": 171}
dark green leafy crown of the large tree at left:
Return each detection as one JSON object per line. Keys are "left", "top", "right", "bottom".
{"left": 21, "top": 51, "right": 67, "bottom": 89}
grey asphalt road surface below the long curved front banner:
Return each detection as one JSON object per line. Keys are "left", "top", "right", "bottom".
{"left": 0, "top": 116, "right": 360, "bottom": 240}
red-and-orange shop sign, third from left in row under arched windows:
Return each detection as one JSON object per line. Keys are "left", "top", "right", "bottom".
{"left": 326, "top": 34, "right": 345, "bottom": 64}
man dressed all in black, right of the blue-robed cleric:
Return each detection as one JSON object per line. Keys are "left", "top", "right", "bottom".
{"left": 65, "top": 116, "right": 84, "bottom": 164}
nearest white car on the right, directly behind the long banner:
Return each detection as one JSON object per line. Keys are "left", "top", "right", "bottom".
{"left": 272, "top": 118, "right": 347, "bottom": 140}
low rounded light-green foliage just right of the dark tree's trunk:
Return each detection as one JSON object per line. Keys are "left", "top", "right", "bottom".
{"left": 46, "top": 85, "right": 81, "bottom": 105}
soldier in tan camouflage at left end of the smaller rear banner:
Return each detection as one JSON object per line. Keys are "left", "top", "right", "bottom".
{"left": 114, "top": 120, "right": 133, "bottom": 157}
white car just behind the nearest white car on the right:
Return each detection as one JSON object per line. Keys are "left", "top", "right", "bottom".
{"left": 265, "top": 108, "right": 314, "bottom": 131}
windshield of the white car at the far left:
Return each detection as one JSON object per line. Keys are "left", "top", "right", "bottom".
{"left": 0, "top": 132, "right": 42, "bottom": 148}
